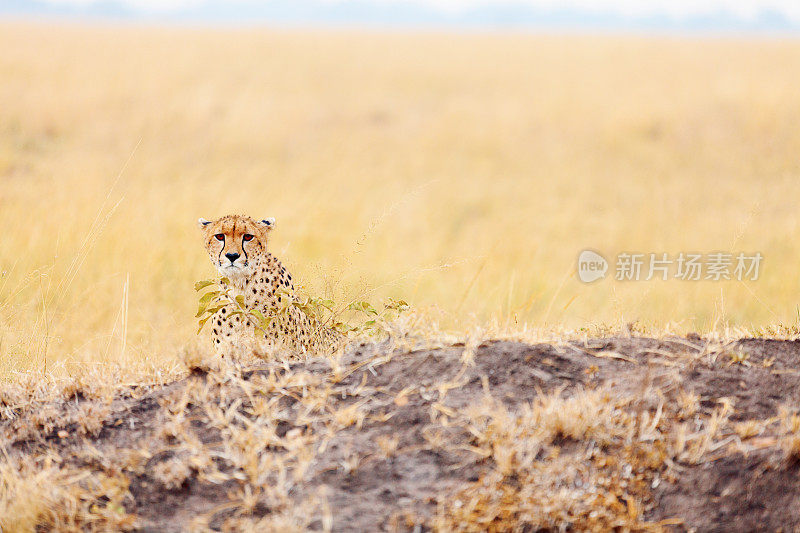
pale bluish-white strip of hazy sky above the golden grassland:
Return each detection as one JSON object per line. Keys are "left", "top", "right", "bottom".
{"left": 0, "top": 0, "right": 800, "bottom": 35}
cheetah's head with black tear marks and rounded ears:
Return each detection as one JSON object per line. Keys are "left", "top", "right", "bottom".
{"left": 197, "top": 215, "right": 275, "bottom": 279}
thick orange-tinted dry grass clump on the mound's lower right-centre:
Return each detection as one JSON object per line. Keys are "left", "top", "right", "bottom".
{"left": 435, "top": 391, "right": 656, "bottom": 531}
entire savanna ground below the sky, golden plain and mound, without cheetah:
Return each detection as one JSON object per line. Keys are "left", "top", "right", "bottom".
{"left": 6, "top": 22, "right": 800, "bottom": 531}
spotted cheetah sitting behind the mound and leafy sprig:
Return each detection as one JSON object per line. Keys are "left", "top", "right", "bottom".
{"left": 197, "top": 215, "right": 344, "bottom": 356}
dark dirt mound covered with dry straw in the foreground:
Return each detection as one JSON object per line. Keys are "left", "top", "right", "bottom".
{"left": 0, "top": 337, "right": 800, "bottom": 531}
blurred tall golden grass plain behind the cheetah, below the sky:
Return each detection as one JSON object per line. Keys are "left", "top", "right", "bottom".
{"left": 0, "top": 22, "right": 800, "bottom": 374}
